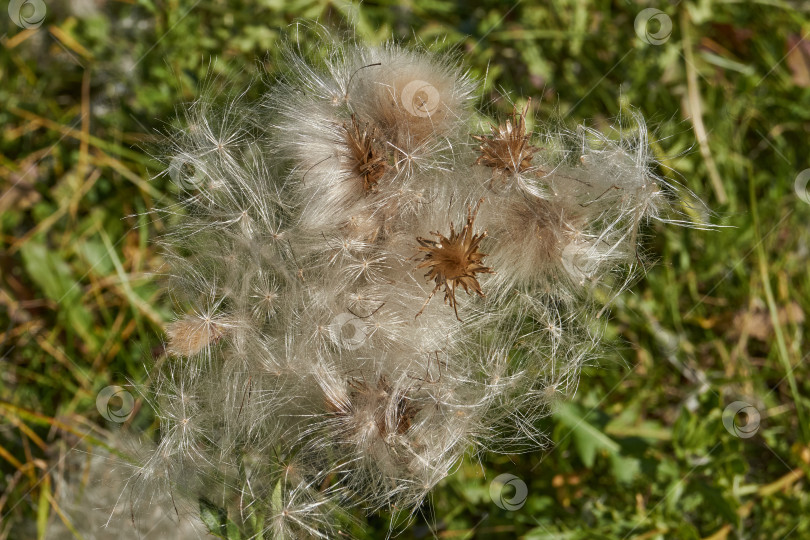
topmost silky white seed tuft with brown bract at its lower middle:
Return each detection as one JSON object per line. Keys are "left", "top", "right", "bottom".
{"left": 263, "top": 35, "right": 476, "bottom": 245}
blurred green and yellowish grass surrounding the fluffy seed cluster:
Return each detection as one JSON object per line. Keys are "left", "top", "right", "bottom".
{"left": 0, "top": 0, "right": 810, "bottom": 540}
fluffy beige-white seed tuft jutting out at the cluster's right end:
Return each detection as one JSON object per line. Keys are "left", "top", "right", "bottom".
{"left": 474, "top": 113, "right": 694, "bottom": 306}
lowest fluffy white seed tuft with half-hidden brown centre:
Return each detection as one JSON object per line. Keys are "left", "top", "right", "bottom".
{"left": 303, "top": 360, "right": 480, "bottom": 509}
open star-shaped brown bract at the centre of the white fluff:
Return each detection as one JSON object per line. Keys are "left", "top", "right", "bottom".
{"left": 416, "top": 199, "right": 494, "bottom": 321}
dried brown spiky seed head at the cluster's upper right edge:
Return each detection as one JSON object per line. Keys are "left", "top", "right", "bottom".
{"left": 473, "top": 99, "right": 538, "bottom": 180}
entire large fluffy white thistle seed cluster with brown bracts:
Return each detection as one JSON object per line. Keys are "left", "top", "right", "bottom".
{"left": 140, "top": 24, "right": 708, "bottom": 538}
